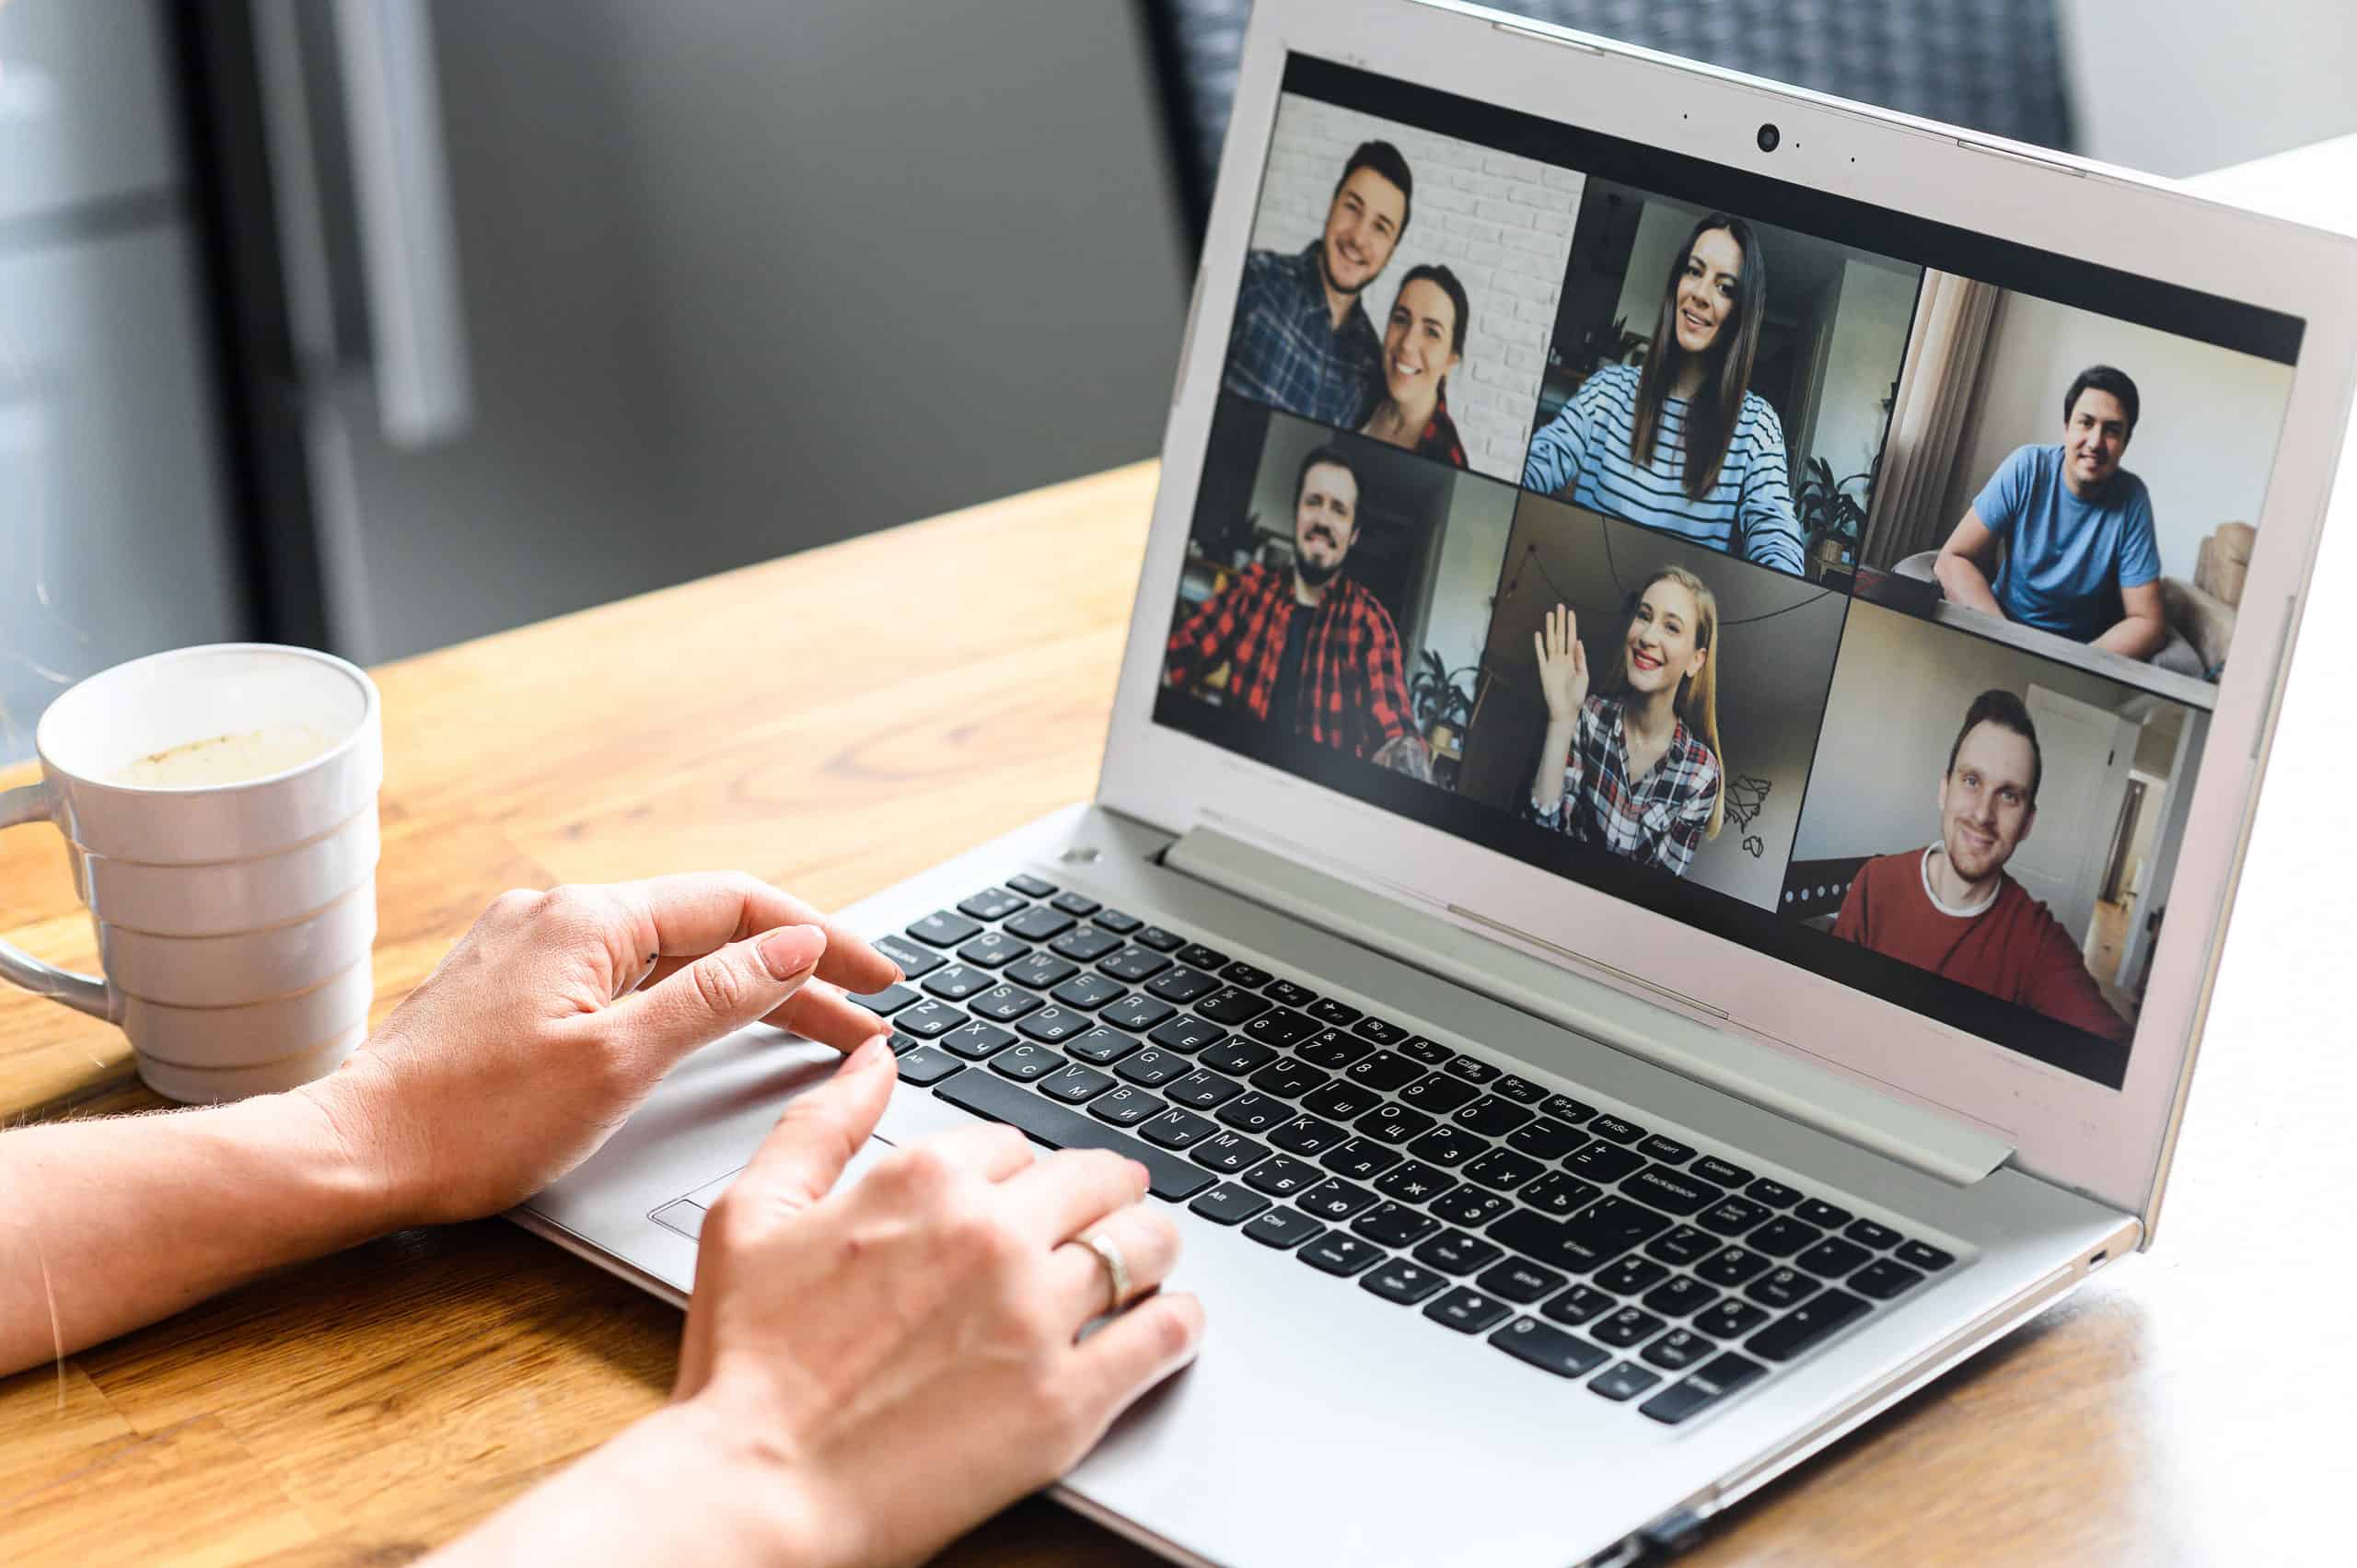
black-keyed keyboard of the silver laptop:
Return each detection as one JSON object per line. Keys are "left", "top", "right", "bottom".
{"left": 855, "top": 875, "right": 1956, "bottom": 1424}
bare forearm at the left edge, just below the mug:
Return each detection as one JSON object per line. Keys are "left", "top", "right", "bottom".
{"left": 0, "top": 1094, "right": 394, "bottom": 1372}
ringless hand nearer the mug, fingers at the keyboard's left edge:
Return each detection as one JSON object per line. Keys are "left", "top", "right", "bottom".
{"left": 299, "top": 873, "right": 898, "bottom": 1228}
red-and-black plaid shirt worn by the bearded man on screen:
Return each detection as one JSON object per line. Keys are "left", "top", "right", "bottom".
{"left": 1162, "top": 566, "right": 1407, "bottom": 757}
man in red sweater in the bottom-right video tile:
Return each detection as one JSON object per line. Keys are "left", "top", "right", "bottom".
{"left": 1834, "top": 691, "right": 2133, "bottom": 1044}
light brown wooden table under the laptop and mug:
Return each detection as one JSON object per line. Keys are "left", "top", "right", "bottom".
{"left": 0, "top": 144, "right": 2357, "bottom": 1568}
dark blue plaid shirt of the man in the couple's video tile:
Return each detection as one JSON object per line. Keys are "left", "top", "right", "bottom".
{"left": 1221, "top": 240, "right": 1384, "bottom": 429}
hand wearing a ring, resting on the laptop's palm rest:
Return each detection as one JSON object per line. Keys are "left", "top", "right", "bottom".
{"left": 674, "top": 1044, "right": 1202, "bottom": 1568}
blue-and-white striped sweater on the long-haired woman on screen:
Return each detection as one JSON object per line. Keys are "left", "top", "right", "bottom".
{"left": 1523, "top": 366, "right": 1801, "bottom": 575}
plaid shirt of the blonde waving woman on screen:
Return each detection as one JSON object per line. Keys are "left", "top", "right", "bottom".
{"left": 1529, "top": 693, "right": 1718, "bottom": 877}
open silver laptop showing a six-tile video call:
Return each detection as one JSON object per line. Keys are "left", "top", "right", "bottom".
{"left": 517, "top": 0, "right": 2357, "bottom": 1565}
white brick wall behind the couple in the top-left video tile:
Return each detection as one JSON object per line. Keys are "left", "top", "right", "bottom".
{"left": 1251, "top": 97, "right": 1582, "bottom": 481}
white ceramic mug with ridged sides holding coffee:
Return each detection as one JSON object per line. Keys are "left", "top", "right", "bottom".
{"left": 0, "top": 644, "right": 384, "bottom": 1101}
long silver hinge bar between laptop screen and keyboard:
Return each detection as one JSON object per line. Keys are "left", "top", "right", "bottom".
{"left": 1162, "top": 828, "right": 2013, "bottom": 1186}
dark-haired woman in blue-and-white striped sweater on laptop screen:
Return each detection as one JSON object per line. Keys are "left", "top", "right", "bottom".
{"left": 1523, "top": 212, "right": 1803, "bottom": 575}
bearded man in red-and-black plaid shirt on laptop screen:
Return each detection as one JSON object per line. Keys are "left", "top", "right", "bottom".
{"left": 1165, "top": 446, "right": 1431, "bottom": 778}
